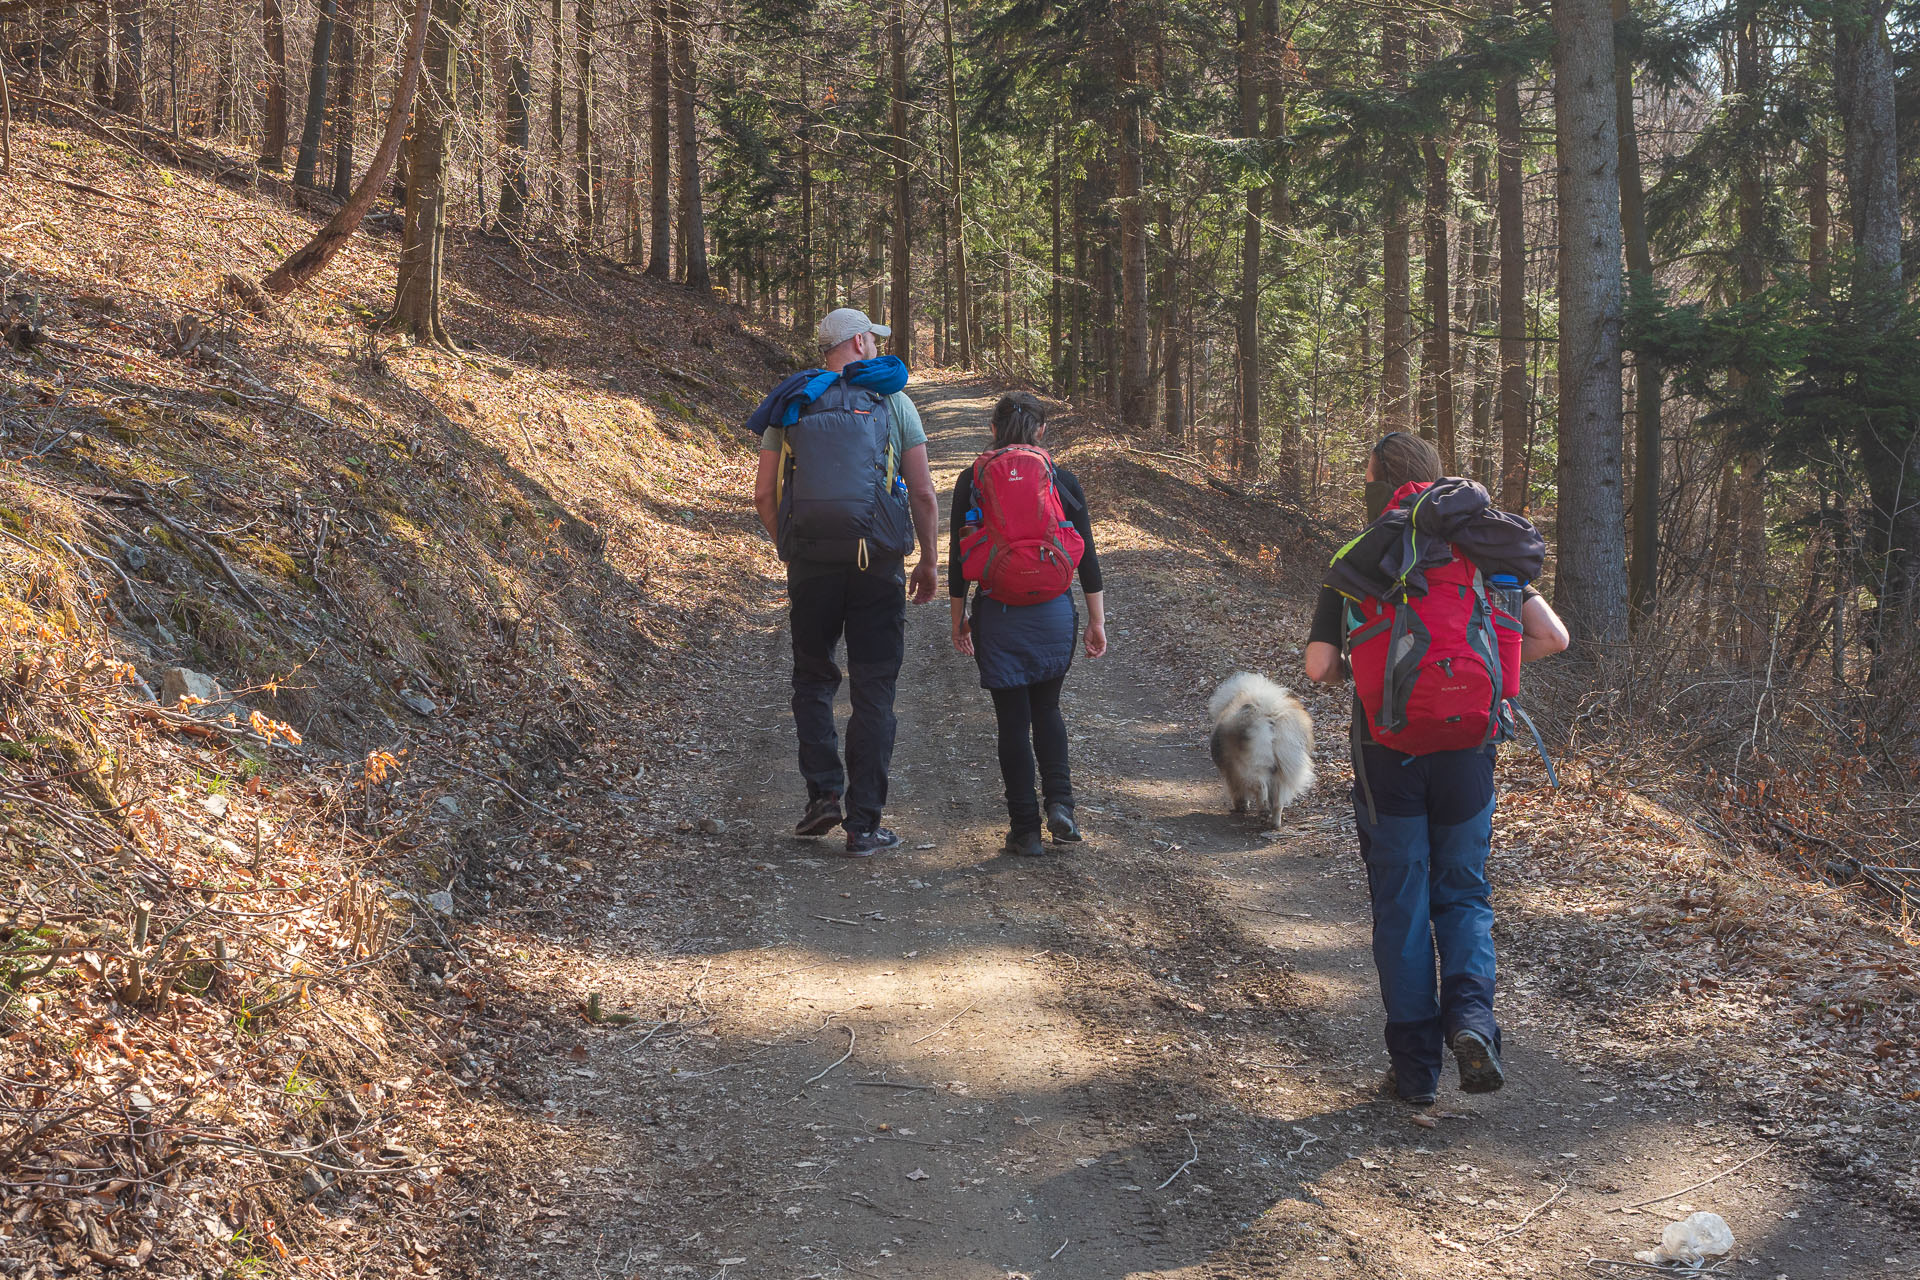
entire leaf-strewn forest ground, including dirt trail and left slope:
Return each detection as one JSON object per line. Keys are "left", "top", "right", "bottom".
{"left": 0, "top": 113, "right": 1920, "bottom": 1280}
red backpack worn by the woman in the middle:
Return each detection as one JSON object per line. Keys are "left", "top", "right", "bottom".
{"left": 960, "top": 445, "right": 1087, "bottom": 604}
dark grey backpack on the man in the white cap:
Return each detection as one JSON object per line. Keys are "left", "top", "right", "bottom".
{"left": 776, "top": 378, "right": 914, "bottom": 568}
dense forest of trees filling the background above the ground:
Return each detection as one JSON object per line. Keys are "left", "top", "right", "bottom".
{"left": 0, "top": 0, "right": 1920, "bottom": 675}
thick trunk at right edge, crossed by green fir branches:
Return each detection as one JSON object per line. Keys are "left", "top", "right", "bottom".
{"left": 1834, "top": 0, "right": 1920, "bottom": 656}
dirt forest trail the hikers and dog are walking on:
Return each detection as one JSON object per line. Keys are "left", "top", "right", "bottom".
{"left": 476, "top": 382, "right": 1920, "bottom": 1280}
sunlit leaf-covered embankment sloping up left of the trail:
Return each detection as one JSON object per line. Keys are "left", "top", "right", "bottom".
{"left": 0, "top": 107, "right": 787, "bottom": 1274}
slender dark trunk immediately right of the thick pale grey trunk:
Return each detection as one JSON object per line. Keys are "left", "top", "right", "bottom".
{"left": 1613, "top": 0, "right": 1667, "bottom": 626}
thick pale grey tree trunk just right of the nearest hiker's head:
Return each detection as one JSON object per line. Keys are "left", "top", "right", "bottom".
{"left": 1553, "top": 0, "right": 1626, "bottom": 645}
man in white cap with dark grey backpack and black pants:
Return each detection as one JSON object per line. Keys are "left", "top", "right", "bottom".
{"left": 747, "top": 307, "right": 939, "bottom": 858}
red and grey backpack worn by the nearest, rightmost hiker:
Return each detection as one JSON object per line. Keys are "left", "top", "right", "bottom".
{"left": 1346, "top": 484, "right": 1523, "bottom": 756}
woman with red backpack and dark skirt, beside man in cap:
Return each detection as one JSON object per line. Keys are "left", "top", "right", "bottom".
{"left": 947, "top": 391, "right": 1106, "bottom": 856}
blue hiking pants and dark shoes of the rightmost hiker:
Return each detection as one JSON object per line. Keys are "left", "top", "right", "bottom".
{"left": 1354, "top": 743, "right": 1500, "bottom": 1096}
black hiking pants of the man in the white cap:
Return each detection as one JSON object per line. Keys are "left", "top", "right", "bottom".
{"left": 787, "top": 560, "right": 906, "bottom": 831}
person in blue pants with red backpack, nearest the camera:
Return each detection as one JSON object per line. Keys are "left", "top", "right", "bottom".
{"left": 1306, "top": 432, "right": 1567, "bottom": 1105}
